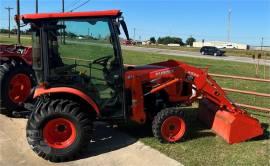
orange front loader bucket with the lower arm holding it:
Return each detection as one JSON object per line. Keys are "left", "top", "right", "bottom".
{"left": 180, "top": 64, "right": 263, "bottom": 144}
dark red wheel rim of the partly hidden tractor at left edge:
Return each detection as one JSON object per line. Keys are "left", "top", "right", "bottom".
{"left": 8, "top": 73, "right": 32, "bottom": 104}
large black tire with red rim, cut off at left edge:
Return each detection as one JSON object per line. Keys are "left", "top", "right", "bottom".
{"left": 0, "top": 61, "right": 35, "bottom": 115}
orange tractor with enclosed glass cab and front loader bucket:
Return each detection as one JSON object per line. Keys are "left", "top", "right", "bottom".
{"left": 21, "top": 10, "right": 263, "bottom": 161}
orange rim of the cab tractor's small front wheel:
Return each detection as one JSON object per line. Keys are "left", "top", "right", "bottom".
{"left": 161, "top": 116, "right": 186, "bottom": 142}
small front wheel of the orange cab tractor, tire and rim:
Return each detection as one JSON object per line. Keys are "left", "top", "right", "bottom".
{"left": 152, "top": 108, "right": 187, "bottom": 143}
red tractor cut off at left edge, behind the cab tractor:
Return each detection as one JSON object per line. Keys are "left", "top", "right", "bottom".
{"left": 0, "top": 44, "right": 35, "bottom": 115}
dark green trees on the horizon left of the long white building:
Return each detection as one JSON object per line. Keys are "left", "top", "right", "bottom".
{"left": 150, "top": 36, "right": 196, "bottom": 46}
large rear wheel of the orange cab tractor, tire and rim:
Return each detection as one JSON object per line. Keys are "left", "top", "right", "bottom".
{"left": 26, "top": 99, "right": 92, "bottom": 162}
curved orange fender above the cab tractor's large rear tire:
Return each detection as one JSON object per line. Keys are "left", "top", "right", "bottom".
{"left": 33, "top": 87, "right": 100, "bottom": 116}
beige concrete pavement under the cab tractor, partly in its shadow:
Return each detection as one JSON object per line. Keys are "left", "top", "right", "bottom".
{"left": 0, "top": 115, "right": 181, "bottom": 166}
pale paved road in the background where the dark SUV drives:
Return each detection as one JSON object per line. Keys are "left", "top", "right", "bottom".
{"left": 122, "top": 46, "right": 270, "bottom": 66}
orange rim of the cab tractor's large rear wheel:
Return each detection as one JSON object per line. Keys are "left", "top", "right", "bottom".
{"left": 43, "top": 118, "right": 76, "bottom": 149}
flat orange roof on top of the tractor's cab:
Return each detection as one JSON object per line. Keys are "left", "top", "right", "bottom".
{"left": 21, "top": 10, "right": 121, "bottom": 21}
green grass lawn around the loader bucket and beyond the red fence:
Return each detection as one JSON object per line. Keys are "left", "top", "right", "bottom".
{"left": 0, "top": 33, "right": 270, "bottom": 165}
